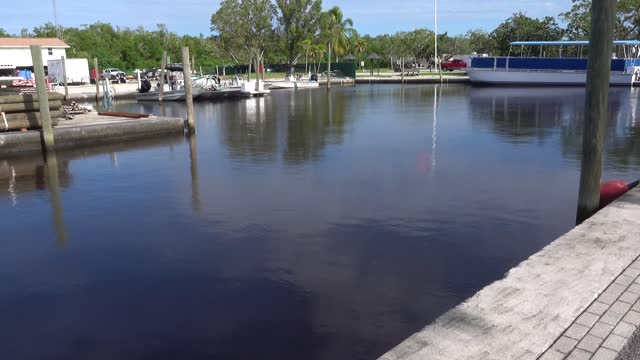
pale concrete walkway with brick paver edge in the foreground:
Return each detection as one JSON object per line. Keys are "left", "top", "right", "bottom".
{"left": 381, "top": 188, "right": 640, "bottom": 360}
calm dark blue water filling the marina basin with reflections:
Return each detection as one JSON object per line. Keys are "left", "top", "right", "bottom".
{"left": 0, "top": 85, "right": 640, "bottom": 360}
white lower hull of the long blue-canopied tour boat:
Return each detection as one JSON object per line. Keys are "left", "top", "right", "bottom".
{"left": 467, "top": 68, "right": 633, "bottom": 86}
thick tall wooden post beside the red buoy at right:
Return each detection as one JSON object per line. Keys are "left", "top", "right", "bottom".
{"left": 576, "top": 0, "right": 616, "bottom": 224}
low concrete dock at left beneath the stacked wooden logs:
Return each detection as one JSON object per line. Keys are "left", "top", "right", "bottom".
{"left": 0, "top": 113, "right": 185, "bottom": 155}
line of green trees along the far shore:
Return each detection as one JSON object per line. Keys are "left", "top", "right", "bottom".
{"left": 0, "top": 0, "right": 640, "bottom": 71}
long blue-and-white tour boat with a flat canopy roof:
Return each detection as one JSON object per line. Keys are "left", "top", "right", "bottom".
{"left": 466, "top": 40, "right": 640, "bottom": 86}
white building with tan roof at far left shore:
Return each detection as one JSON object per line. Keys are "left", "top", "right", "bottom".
{"left": 0, "top": 38, "right": 70, "bottom": 69}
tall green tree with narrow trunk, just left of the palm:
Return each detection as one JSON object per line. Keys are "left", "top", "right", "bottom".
{"left": 276, "top": 0, "right": 322, "bottom": 65}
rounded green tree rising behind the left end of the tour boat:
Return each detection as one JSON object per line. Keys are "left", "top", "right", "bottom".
{"left": 491, "top": 12, "right": 563, "bottom": 55}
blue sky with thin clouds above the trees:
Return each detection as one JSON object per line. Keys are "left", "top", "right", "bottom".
{"left": 5, "top": 0, "right": 571, "bottom": 35}
